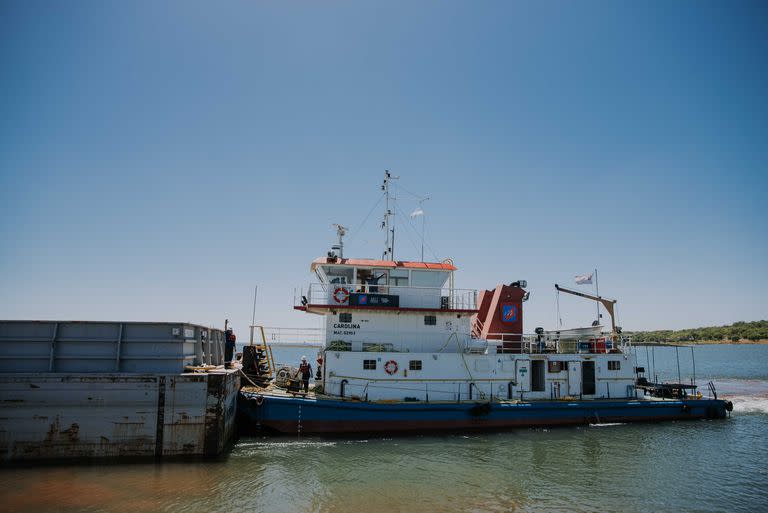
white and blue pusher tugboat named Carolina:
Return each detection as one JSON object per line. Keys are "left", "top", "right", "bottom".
{"left": 238, "top": 173, "right": 732, "bottom": 434}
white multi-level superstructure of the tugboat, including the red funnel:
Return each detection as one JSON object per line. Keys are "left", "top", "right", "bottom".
{"left": 296, "top": 255, "right": 636, "bottom": 401}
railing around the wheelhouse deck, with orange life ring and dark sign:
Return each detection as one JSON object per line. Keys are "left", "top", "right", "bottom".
{"left": 295, "top": 283, "right": 477, "bottom": 310}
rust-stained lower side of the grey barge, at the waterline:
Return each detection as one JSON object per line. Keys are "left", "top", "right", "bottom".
{"left": 0, "top": 372, "right": 239, "bottom": 462}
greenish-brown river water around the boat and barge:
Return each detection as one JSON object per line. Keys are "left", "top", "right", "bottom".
{"left": 0, "top": 345, "right": 768, "bottom": 513}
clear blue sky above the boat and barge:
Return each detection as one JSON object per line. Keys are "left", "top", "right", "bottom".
{"left": 0, "top": 1, "right": 768, "bottom": 337}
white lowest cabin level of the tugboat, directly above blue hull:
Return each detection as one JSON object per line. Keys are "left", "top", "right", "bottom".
{"left": 324, "top": 351, "right": 636, "bottom": 401}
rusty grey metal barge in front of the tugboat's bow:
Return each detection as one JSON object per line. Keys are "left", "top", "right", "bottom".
{"left": 0, "top": 321, "right": 240, "bottom": 463}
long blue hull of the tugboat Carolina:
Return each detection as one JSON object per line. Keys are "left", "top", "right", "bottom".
{"left": 238, "top": 393, "right": 731, "bottom": 434}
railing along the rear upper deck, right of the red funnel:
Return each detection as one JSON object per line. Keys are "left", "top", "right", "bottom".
{"left": 484, "top": 333, "right": 629, "bottom": 354}
